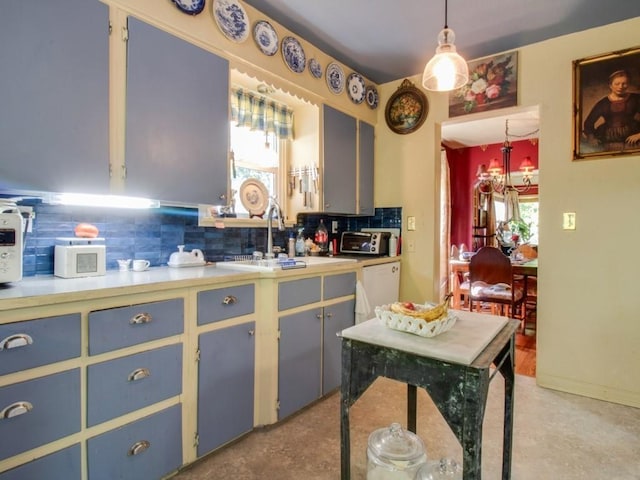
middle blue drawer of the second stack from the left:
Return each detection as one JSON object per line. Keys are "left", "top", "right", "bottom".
{"left": 87, "top": 344, "right": 182, "bottom": 427}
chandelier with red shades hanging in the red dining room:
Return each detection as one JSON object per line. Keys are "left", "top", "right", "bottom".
{"left": 476, "top": 120, "right": 537, "bottom": 195}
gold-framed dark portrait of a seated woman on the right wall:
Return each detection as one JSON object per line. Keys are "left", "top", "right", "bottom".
{"left": 573, "top": 47, "right": 640, "bottom": 160}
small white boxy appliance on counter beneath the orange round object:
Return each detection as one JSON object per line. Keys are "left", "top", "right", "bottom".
{"left": 53, "top": 237, "right": 107, "bottom": 278}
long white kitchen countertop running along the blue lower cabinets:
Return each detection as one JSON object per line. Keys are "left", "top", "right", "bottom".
{"left": 0, "top": 257, "right": 400, "bottom": 311}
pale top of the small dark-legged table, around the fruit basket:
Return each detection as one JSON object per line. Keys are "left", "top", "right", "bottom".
{"left": 340, "top": 310, "right": 509, "bottom": 365}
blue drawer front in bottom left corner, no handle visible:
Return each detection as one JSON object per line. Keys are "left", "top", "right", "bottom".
{"left": 0, "top": 443, "right": 82, "bottom": 480}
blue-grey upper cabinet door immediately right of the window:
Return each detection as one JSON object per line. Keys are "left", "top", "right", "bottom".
{"left": 322, "top": 105, "right": 358, "bottom": 214}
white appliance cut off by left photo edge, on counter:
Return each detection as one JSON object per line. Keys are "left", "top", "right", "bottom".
{"left": 0, "top": 202, "right": 23, "bottom": 283}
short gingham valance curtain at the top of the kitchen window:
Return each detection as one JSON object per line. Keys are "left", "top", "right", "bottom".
{"left": 231, "top": 88, "right": 293, "bottom": 140}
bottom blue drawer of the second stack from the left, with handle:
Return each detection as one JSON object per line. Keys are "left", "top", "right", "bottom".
{"left": 87, "top": 405, "right": 182, "bottom": 480}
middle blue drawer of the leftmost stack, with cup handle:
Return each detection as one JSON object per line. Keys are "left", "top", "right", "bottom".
{"left": 0, "top": 368, "right": 80, "bottom": 460}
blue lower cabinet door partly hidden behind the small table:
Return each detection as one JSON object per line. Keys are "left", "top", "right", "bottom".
{"left": 322, "top": 300, "right": 356, "bottom": 395}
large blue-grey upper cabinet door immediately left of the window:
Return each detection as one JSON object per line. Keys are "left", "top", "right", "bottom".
{"left": 125, "top": 17, "right": 229, "bottom": 204}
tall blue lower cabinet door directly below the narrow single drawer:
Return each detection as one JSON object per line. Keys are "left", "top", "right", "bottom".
{"left": 198, "top": 322, "right": 255, "bottom": 457}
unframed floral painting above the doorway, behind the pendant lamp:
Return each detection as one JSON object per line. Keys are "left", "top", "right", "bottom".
{"left": 449, "top": 51, "right": 518, "bottom": 117}
